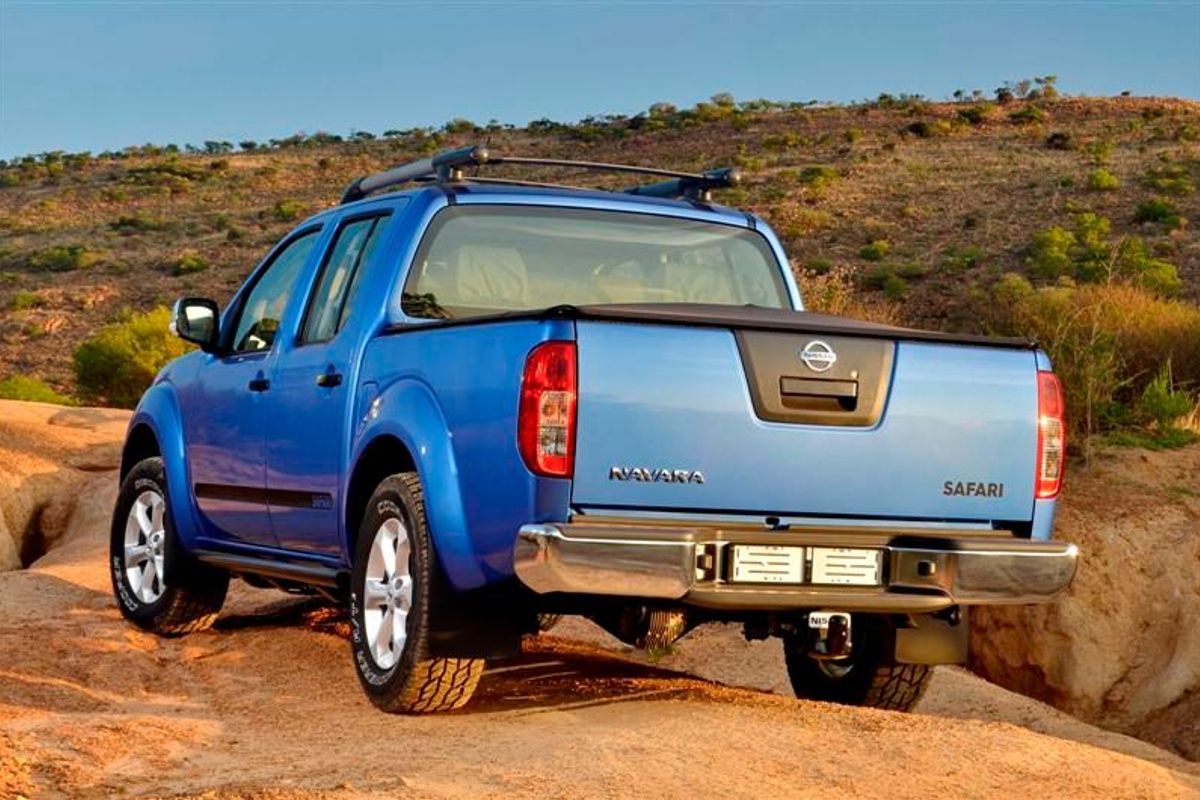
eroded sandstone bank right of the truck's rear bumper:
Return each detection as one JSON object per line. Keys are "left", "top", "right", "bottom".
{"left": 971, "top": 447, "right": 1200, "bottom": 758}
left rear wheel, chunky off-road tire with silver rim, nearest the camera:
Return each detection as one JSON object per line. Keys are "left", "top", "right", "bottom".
{"left": 350, "top": 473, "right": 485, "bottom": 714}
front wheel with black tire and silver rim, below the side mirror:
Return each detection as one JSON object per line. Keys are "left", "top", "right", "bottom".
{"left": 108, "top": 458, "right": 229, "bottom": 636}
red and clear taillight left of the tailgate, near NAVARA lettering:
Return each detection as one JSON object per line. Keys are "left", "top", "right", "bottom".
{"left": 517, "top": 342, "right": 577, "bottom": 477}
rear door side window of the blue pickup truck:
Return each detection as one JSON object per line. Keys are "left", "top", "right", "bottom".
{"left": 300, "top": 216, "right": 388, "bottom": 343}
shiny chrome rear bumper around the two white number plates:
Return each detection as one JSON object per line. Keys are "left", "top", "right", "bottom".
{"left": 514, "top": 518, "right": 1079, "bottom": 613}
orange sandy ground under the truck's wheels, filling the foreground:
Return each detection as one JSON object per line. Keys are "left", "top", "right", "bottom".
{"left": 0, "top": 400, "right": 1200, "bottom": 799}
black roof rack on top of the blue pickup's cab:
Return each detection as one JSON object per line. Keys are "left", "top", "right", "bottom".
{"left": 342, "top": 145, "right": 742, "bottom": 204}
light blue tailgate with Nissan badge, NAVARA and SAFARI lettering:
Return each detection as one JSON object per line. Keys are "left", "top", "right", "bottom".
{"left": 572, "top": 319, "right": 1038, "bottom": 522}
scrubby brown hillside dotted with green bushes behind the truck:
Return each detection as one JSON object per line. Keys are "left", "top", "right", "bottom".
{"left": 0, "top": 97, "right": 1200, "bottom": 391}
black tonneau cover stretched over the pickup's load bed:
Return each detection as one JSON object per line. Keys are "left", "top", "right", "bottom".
{"left": 391, "top": 303, "right": 1038, "bottom": 350}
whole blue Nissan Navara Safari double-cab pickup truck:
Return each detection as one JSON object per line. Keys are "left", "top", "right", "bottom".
{"left": 110, "top": 148, "right": 1076, "bottom": 712}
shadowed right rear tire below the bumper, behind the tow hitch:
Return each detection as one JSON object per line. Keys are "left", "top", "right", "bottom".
{"left": 784, "top": 614, "right": 934, "bottom": 711}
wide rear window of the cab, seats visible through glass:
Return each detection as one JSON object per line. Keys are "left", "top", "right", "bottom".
{"left": 403, "top": 206, "right": 790, "bottom": 319}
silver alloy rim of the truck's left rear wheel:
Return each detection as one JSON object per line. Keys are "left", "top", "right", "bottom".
{"left": 362, "top": 517, "right": 413, "bottom": 669}
